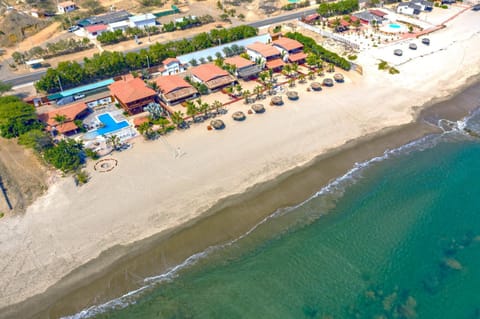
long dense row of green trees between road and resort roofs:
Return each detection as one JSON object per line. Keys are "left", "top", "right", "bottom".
{"left": 35, "top": 26, "right": 258, "bottom": 93}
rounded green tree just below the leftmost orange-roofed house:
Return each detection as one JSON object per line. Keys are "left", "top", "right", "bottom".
{"left": 43, "top": 139, "right": 83, "bottom": 173}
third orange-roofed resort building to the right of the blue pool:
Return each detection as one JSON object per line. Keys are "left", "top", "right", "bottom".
{"left": 190, "top": 63, "right": 236, "bottom": 92}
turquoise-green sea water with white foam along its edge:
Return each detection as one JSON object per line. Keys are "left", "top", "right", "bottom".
{"left": 75, "top": 111, "right": 480, "bottom": 319}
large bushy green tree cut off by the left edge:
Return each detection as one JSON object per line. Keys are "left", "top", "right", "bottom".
{"left": 0, "top": 96, "right": 43, "bottom": 138}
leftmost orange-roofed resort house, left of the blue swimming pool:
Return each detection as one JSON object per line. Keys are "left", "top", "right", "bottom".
{"left": 38, "top": 102, "right": 89, "bottom": 135}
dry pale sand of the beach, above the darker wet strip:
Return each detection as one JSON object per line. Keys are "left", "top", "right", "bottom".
{"left": 0, "top": 11, "right": 480, "bottom": 317}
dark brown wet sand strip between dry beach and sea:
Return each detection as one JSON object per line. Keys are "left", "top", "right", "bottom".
{"left": 2, "top": 75, "right": 480, "bottom": 318}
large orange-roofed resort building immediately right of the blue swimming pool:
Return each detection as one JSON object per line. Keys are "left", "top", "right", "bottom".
{"left": 108, "top": 75, "right": 157, "bottom": 114}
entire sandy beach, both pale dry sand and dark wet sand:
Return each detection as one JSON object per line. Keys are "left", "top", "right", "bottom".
{"left": 0, "top": 8, "right": 480, "bottom": 318}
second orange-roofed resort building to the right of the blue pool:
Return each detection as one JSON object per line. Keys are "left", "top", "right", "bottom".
{"left": 155, "top": 75, "right": 198, "bottom": 105}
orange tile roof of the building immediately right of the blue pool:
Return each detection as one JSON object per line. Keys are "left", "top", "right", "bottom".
{"left": 108, "top": 78, "right": 156, "bottom": 104}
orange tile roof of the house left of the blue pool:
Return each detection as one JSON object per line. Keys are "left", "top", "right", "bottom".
{"left": 38, "top": 102, "right": 88, "bottom": 134}
